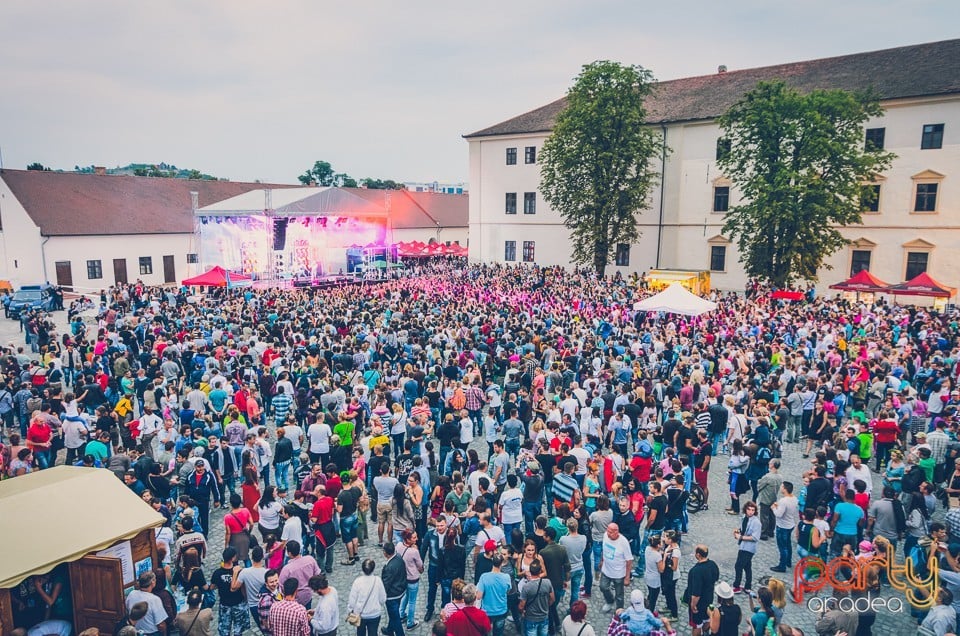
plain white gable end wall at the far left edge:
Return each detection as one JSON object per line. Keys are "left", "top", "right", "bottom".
{"left": 0, "top": 179, "right": 44, "bottom": 289}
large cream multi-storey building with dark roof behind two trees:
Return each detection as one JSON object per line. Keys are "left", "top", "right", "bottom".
{"left": 465, "top": 39, "right": 960, "bottom": 289}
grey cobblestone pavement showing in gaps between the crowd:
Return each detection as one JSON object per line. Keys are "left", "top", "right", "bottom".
{"left": 0, "top": 312, "right": 917, "bottom": 636}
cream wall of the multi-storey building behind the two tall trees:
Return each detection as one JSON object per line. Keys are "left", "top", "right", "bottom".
{"left": 469, "top": 96, "right": 960, "bottom": 289}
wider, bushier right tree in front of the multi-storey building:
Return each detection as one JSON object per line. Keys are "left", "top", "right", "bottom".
{"left": 718, "top": 80, "right": 894, "bottom": 287}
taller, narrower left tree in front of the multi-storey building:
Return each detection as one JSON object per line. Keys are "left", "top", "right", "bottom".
{"left": 540, "top": 61, "right": 667, "bottom": 276}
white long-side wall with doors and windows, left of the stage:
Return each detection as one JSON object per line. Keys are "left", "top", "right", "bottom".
{"left": 44, "top": 234, "right": 200, "bottom": 292}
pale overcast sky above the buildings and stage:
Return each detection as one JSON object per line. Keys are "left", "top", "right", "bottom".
{"left": 0, "top": 0, "right": 960, "bottom": 183}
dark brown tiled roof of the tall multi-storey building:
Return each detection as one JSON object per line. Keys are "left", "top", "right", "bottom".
{"left": 464, "top": 39, "right": 960, "bottom": 139}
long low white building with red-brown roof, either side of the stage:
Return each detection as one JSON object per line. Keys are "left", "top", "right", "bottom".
{"left": 0, "top": 170, "right": 467, "bottom": 293}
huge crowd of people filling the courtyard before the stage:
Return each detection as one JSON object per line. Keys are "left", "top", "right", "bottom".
{"left": 0, "top": 264, "right": 960, "bottom": 636}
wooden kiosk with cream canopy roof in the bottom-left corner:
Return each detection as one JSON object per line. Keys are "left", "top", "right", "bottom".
{"left": 0, "top": 466, "right": 164, "bottom": 634}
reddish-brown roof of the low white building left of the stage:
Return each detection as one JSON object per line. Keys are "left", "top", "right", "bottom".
{"left": 0, "top": 170, "right": 297, "bottom": 236}
